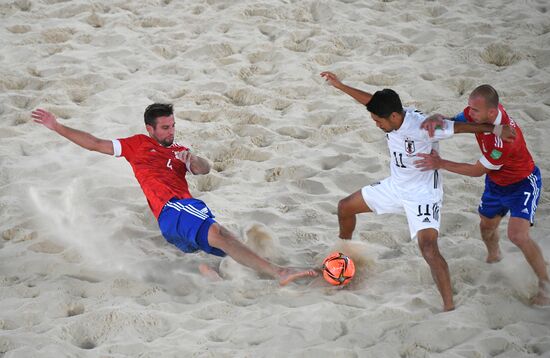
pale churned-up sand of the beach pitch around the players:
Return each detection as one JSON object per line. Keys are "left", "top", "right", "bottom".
{"left": 0, "top": 0, "right": 550, "bottom": 358}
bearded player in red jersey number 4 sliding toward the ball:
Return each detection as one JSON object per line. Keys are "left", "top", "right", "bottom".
{"left": 32, "top": 103, "right": 317, "bottom": 285}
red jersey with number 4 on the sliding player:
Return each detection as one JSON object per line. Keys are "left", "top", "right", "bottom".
{"left": 113, "top": 134, "right": 192, "bottom": 219}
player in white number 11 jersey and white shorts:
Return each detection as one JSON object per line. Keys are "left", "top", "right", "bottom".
{"left": 321, "top": 72, "right": 516, "bottom": 311}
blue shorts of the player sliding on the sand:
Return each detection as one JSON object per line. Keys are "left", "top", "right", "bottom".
{"left": 158, "top": 199, "right": 225, "bottom": 256}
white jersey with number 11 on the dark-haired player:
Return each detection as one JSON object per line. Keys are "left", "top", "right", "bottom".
{"left": 386, "top": 108, "right": 454, "bottom": 201}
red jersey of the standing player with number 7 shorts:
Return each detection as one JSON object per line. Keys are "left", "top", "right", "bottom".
{"left": 464, "top": 104, "right": 535, "bottom": 186}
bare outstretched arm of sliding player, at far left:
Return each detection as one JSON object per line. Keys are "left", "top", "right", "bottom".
{"left": 32, "top": 108, "right": 114, "bottom": 155}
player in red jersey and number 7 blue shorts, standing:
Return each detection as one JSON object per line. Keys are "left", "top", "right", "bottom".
{"left": 416, "top": 85, "right": 550, "bottom": 305}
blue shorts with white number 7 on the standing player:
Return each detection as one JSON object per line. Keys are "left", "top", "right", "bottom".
{"left": 478, "top": 167, "right": 542, "bottom": 225}
